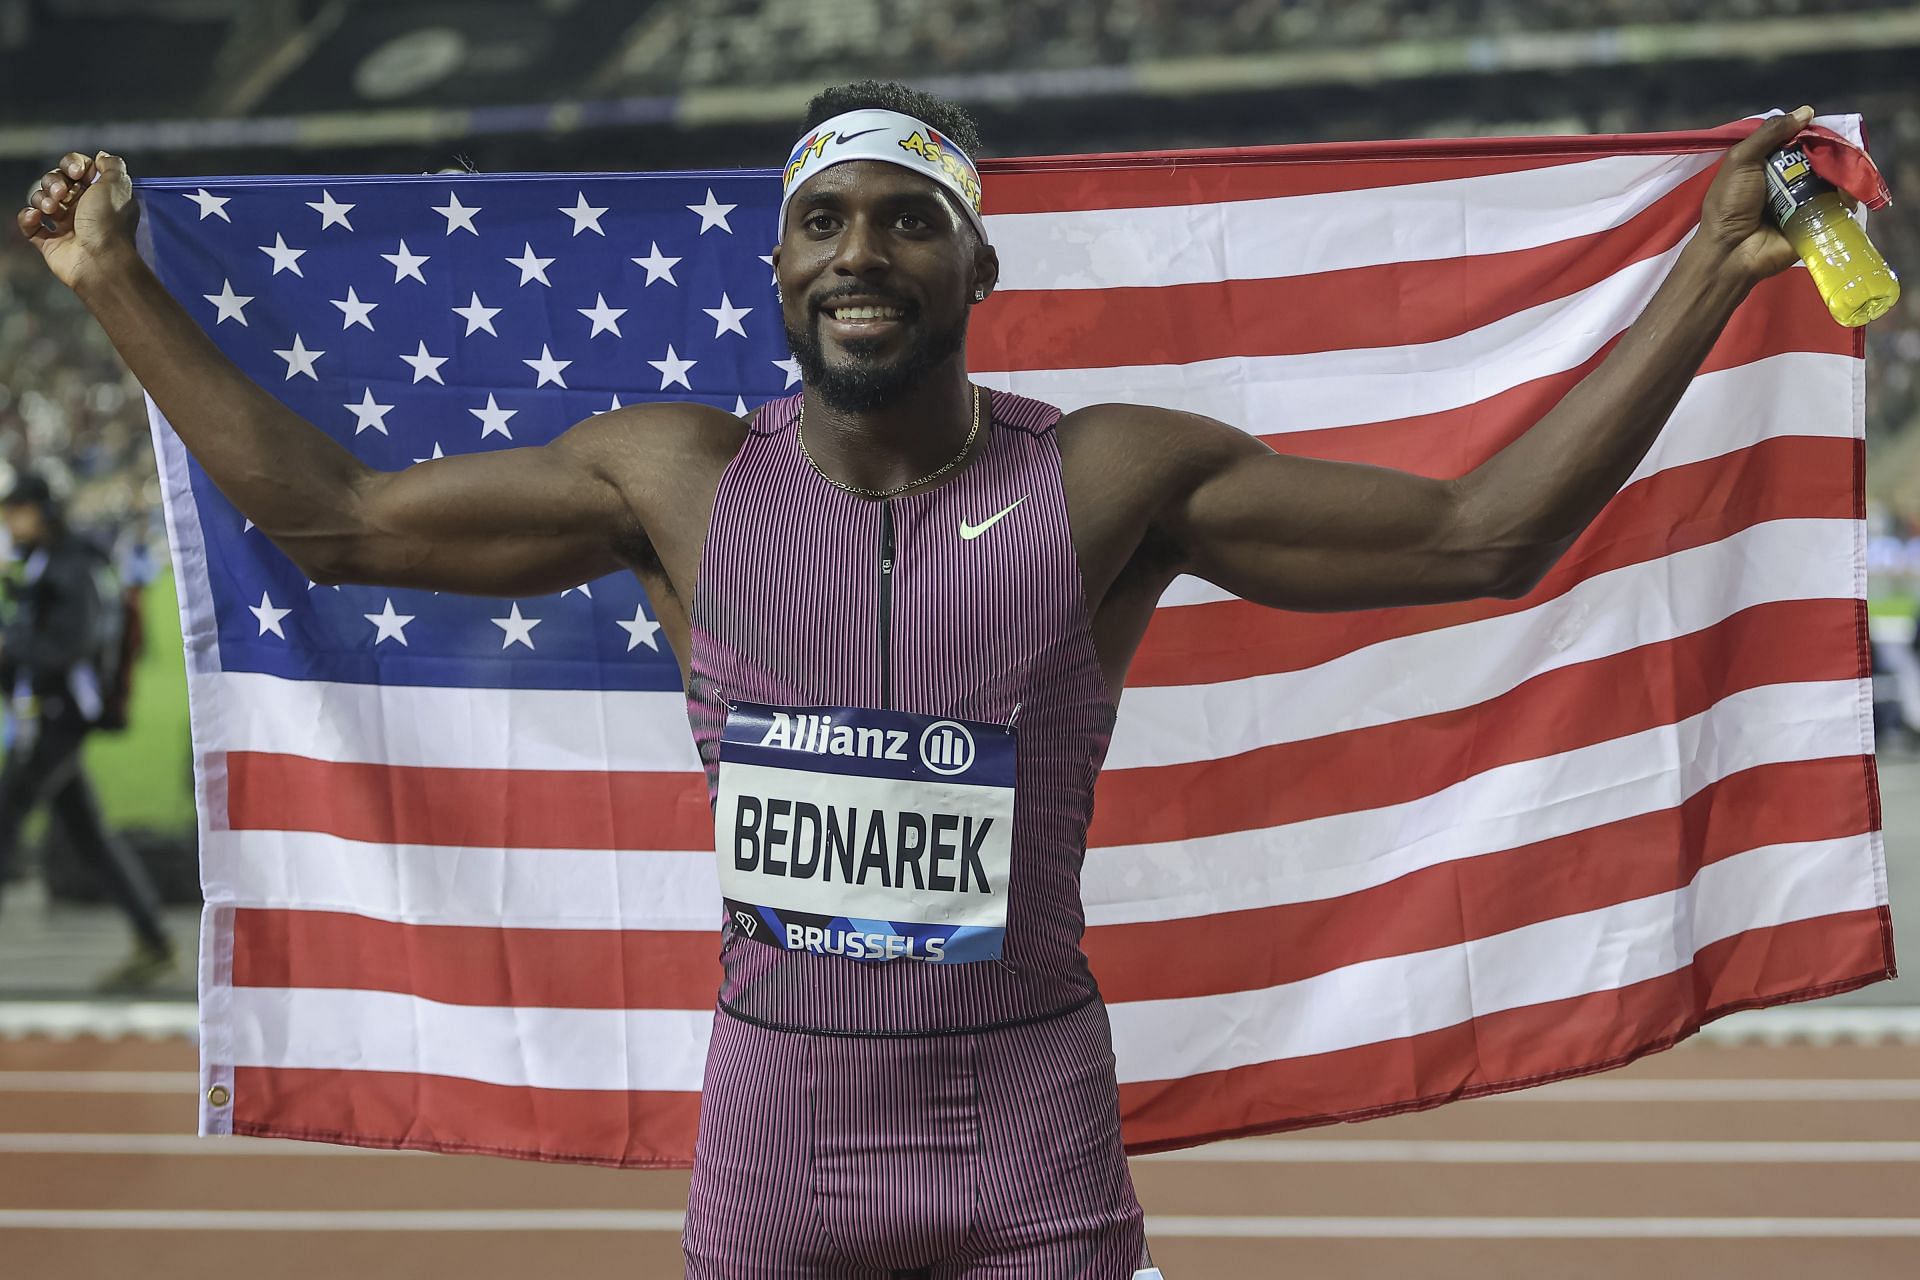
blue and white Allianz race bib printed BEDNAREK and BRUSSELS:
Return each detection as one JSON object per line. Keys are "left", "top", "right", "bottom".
{"left": 714, "top": 702, "right": 1016, "bottom": 963}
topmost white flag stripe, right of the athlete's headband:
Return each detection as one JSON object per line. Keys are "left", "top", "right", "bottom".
{"left": 987, "top": 152, "right": 1720, "bottom": 290}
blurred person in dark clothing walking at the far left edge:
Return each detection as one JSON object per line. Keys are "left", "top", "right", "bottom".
{"left": 0, "top": 474, "right": 175, "bottom": 990}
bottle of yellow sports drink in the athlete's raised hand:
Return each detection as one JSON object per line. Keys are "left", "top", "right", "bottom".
{"left": 1766, "top": 144, "right": 1901, "bottom": 328}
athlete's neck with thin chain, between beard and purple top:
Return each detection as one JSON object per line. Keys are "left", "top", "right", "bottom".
{"left": 806, "top": 361, "right": 985, "bottom": 489}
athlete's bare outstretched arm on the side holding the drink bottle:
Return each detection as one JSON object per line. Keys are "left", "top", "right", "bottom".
{"left": 1131, "top": 107, "right": 1811, "bottom": 608}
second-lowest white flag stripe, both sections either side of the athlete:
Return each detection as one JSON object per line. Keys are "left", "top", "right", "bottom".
{"left": 207, "top": 681, "right": 1862, "bottom": 931}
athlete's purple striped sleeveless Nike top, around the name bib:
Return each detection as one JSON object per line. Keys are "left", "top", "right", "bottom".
{"left": 687, "top": 393, "right": 1114, "bottom": 1034}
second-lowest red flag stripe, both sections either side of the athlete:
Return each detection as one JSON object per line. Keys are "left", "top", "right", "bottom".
{"left": 217, "top": 756, "right": 1874, "bottom": 1009}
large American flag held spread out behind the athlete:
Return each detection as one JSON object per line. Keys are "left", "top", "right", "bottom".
{"left": 138, "top": 117, "right": 1893, "bottom": 1165}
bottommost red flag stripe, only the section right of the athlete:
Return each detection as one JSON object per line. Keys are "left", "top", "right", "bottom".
{"left": 1119, "top": 908, "right": 1893, "bottom": 1155}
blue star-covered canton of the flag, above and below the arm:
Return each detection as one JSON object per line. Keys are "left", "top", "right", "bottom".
{"left": 136, "top": 169, "right": 799, "bottom": 689}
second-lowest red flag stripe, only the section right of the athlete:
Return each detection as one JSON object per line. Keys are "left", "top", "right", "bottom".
{"left": 1085, "top": 756, "right": 1878, "bottom": 1004}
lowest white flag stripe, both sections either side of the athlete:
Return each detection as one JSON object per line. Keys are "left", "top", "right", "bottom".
{"left": 214, "top": 837, "right": 1874, "bottom": 1092}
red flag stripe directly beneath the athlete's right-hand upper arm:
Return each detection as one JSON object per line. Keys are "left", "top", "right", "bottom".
{"left": 1127, "top": 436, "right": 1864, "bottom": 689}
